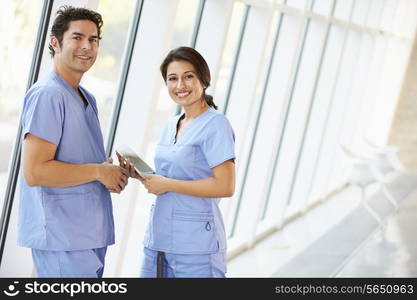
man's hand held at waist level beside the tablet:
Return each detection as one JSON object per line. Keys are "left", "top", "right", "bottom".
{"left": 99, "top": 157, "right": 129, "bottom": 194}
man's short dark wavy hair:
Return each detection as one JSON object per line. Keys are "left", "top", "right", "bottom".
{"left": 48, "top": 5, "right": 103, "bottom": 57}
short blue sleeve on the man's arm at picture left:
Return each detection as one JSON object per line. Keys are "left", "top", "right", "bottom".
{"left": 22, "top": 88, "right": 64, "bottom": 145}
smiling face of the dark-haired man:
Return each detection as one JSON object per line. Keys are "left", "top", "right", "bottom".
{"left": 51, "top": 20, "right": 99, "bottom": 73}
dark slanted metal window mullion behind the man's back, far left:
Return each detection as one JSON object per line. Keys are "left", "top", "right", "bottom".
{"left": 0, "top": 0, "right": 54, "bottom": 266}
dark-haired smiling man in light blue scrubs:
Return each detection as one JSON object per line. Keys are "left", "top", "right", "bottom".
{"left": 18, "top": 6, "right": 128, "bottom": 277}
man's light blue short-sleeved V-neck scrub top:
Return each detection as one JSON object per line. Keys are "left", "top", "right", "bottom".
{"left": 18, "top": 72, "right": 114, "bottom": 251}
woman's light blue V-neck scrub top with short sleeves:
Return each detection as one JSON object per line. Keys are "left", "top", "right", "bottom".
{"left": 144, "top": 108, "right": 235, "bottom": 254}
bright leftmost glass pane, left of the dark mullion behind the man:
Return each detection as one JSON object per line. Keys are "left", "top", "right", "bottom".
{"left": 0, "top": 0, "right": 43, "bottom": 207}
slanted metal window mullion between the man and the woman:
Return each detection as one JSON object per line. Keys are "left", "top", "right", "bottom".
{"left": 106, "top": 0, "right": 144, "bottom": 157}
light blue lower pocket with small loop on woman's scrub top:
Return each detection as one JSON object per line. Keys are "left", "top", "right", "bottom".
{"left": 172, "top": 210, "right": 219, "bottom": 254}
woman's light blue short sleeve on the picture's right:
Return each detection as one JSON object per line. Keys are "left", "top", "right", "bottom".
{"left": 201, "top": 115, "right": 235, "bottom": 168}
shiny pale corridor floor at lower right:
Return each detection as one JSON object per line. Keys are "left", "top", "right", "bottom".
{"left": 227, "top": 172, "right": 417, "bottom": 277}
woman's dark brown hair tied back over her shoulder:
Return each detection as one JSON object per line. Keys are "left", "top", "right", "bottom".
{"left": 160, "top": 47, "right": 217, "bottom": 109}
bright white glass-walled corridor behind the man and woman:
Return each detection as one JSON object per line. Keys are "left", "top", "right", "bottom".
{"left": 0, "top": 0, "right": 417, "bottom": 278}
